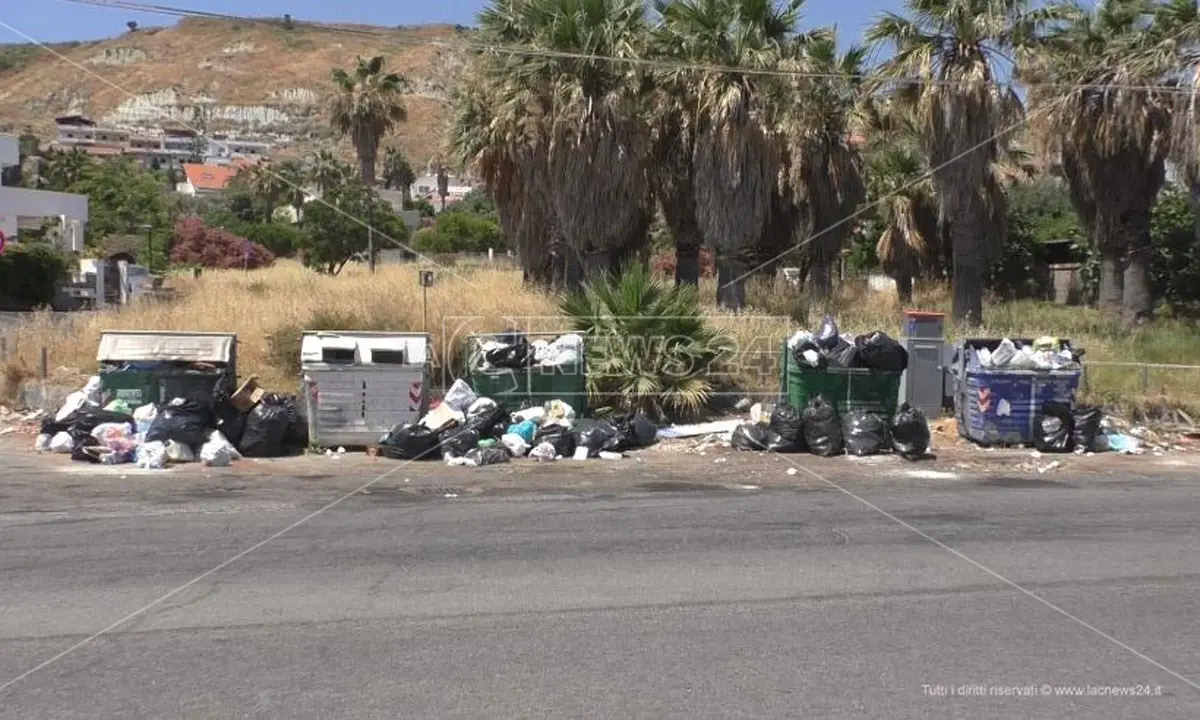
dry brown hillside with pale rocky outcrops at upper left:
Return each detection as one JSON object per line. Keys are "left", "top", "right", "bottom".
{"left": 0, "top": 19, "right": 462, "bottom": 168}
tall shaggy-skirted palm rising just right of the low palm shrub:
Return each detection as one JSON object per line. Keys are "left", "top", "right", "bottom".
{"left": 655, "top": 0, "right": 803, "bottom": 308}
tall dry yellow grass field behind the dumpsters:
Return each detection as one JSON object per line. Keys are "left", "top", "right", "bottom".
{"left": 0, "top": 263, "right": 1200, "bottom": 413}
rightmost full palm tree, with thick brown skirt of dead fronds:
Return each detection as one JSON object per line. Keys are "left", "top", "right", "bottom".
{"left": 1021, "top": 0, "right": 1170, "bottom": 324}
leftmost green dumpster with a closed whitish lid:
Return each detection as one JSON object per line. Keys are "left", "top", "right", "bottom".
{"left": 96, "top": 331, "right": 238, "bottom": 408}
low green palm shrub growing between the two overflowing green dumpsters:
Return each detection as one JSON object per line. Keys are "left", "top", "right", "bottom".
{"left": 560, "top": 265, "right": 733, "bottom": 419}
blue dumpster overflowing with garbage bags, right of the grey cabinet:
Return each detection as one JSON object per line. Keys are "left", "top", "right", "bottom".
{"left": 954, "top": 340, "right": 1081, "bottom": 445}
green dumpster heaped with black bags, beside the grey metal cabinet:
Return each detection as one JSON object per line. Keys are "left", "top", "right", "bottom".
{"left": 779, "top": 341, "right": 904, "bottom": 419}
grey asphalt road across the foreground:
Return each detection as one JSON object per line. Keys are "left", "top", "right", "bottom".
{"left": 0, "top": 473, "right": 1200, "bottom": 719}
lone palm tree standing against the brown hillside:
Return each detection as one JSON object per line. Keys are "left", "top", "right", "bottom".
{"left": 330, "top": 55, "right": 408, "bottom": 185}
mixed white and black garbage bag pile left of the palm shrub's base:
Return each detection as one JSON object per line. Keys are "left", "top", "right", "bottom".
{"left": 379, "top": 376, "right": 659, "bottom": 467}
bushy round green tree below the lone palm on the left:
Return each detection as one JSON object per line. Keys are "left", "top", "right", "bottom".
{"left": 297, "top": 180, "right": 408, "bottom": 275}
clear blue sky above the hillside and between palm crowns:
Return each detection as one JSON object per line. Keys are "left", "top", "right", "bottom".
{"left": 0, "top": 0, "right": 902, "bottom": 43}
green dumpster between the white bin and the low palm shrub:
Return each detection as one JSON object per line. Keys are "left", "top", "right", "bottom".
{"left": 467, "top": 332, "right": 588, "bottom": 418}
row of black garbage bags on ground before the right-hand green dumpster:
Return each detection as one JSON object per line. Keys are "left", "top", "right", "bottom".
{"left": 730, "top": 395, "right": 930, "bottom": 460}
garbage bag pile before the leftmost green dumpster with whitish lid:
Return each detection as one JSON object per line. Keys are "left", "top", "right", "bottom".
{"left": 34, "top": 377, "right": 307, "bottom": 469}
